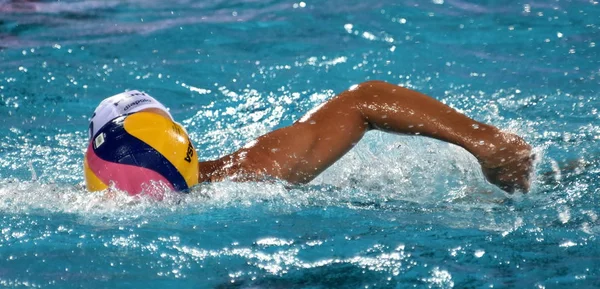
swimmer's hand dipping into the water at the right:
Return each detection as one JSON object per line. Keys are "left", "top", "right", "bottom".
{"left": 476, "top": 132, "right": 535, "bottom": 194}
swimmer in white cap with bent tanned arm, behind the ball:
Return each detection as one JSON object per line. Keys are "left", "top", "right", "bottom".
{"left": 90, "top": 81, "right": 533, "bottom": 193}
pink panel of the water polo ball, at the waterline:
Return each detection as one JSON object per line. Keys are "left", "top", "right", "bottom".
{"left": 86, "top": 143, "right": 175, "bottom": 199}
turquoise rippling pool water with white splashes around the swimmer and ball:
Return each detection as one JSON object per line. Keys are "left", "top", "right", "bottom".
{"left": 0, "top": 0, "right": 600, "bottom": 288}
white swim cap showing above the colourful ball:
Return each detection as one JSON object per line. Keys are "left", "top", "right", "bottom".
{"left": 89, "top": 90, "right": 173, "bottom": 140}
